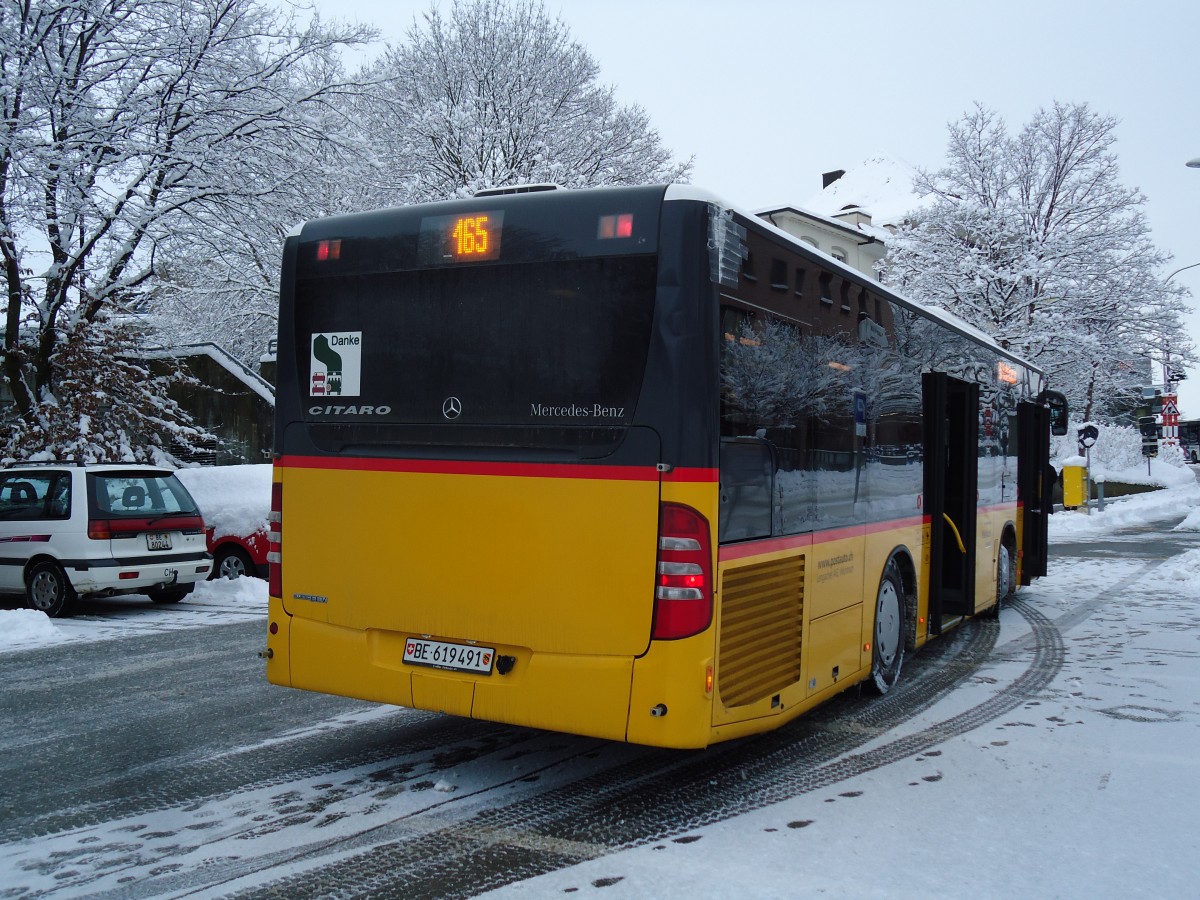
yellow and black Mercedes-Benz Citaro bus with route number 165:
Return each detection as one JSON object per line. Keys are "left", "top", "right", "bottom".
{"left": 265, "top": 185, "right": 1066, "bottom": 748}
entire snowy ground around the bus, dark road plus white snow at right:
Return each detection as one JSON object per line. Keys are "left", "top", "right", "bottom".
{"left": 0, "top": 480, "right": 1200, "bottom": 898}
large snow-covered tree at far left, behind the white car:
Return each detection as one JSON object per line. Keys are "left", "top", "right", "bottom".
{"left": 0, "top": 0, "right": 364, "bottom": 458}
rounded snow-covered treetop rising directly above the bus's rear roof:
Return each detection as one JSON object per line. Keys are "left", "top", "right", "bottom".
{"left": 361, "top": 0, "right": 691, "bottom": 204}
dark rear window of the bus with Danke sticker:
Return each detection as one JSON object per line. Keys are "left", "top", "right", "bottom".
{"left": 295, "top": 256, "right": 655, "bottom": 433}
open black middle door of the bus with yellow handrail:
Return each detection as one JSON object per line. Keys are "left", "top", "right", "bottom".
{"left": 922, "top": 372, "right": 979, "bottom": 635}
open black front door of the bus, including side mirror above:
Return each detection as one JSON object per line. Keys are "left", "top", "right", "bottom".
{"left": 1016, "top": 391, "right": 1067, "bottom": 584}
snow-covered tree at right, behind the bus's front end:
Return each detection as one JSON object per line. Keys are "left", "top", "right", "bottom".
{"left": 883, "top": 103, "right": 1193, "bottom": 419}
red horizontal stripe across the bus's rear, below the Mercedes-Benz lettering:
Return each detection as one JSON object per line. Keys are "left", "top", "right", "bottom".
{"left": 275, "top": 456, "right": 718, "bottom": 484}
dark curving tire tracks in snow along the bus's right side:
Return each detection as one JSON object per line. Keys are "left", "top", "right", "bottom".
{"left": 196, "top": 606, "right": 1062, "bottom": 898}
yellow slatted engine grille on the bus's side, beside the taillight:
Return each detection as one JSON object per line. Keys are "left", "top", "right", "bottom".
{"left": 718, "top": 556, "right": 804, "bottom": 707}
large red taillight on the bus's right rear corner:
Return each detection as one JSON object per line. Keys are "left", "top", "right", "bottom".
{"left": 650, "top": 503, "right": 713, "bottom": 641}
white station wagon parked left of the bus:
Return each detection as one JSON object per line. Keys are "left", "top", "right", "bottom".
{"left": 0, "top": 462, "right": 212, "bottom": 616}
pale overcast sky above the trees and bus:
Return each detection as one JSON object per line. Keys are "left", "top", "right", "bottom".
{"left": 320, "top": 0, "right": 1200, "bottom": 418}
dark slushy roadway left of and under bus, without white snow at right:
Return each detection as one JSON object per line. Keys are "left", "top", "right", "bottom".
{"left": 0, "top": 607, "right": 1012, "bottom": 896}
